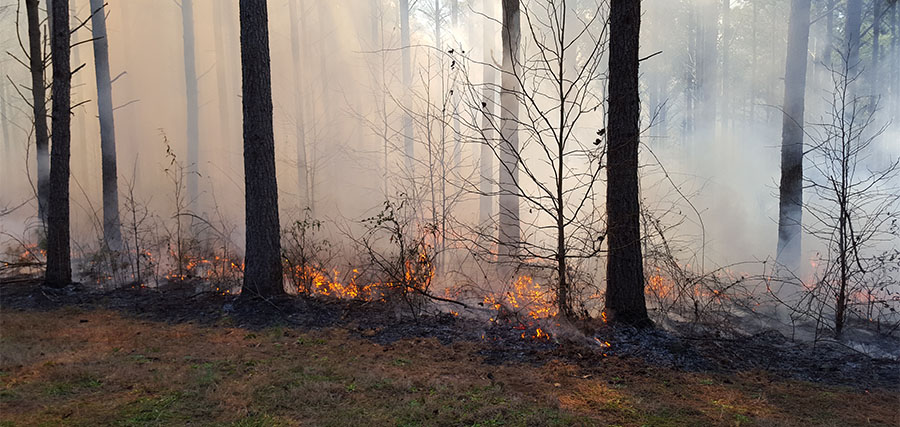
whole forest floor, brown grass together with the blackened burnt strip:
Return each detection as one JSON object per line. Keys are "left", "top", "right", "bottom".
{"left": 0, "top": 281, "right": 900, "bottom": 426}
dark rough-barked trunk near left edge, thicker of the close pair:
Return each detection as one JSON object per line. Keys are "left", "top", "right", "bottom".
{"left": 44, "top": 0, "right": 72, "bottom": 288}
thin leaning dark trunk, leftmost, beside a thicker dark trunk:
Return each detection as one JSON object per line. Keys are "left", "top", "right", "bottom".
{"left": 25, "top": 0, "right": 49, "bottom": 231}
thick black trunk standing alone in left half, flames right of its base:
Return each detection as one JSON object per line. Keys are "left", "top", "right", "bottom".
{"left": 240, "top": 0, "right": 284, "bottom": 297}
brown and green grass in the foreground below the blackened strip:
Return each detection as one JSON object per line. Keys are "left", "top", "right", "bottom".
{"left": 0, "top": 309, "right": 900, "bottom": 426}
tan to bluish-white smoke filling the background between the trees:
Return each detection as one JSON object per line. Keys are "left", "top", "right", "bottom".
{"left": 0, "top": 0, "right": 900, "bottom": 340}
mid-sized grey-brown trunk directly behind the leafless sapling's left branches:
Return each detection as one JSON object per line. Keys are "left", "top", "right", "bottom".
{"left": 499, "top": 0, "right": 521, "bottom": 260}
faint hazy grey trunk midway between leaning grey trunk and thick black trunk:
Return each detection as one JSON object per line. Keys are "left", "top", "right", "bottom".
{"left": 181, "top": 0, "right": 200, "bottom": 213}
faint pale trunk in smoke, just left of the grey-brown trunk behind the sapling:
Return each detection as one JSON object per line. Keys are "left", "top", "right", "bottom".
{"left": 478, "top": 0, "right": 497, "bottom": 226}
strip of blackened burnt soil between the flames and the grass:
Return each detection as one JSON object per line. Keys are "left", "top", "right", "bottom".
{"left": 0, "top": 278, "right": 900, "bottom": 390}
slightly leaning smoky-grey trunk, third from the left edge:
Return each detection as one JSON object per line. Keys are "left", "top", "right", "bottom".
{"left": 91, "top": 0, "right": 122, "bottom": 251}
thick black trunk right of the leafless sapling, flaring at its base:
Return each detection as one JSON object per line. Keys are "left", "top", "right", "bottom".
{"left": 606, "top": 0, "right": 651, "bottom": 326}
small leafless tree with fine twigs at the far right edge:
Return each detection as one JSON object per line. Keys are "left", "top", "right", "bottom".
{"left": 805, "top": 52, "right": 900, "bottom": 337}
